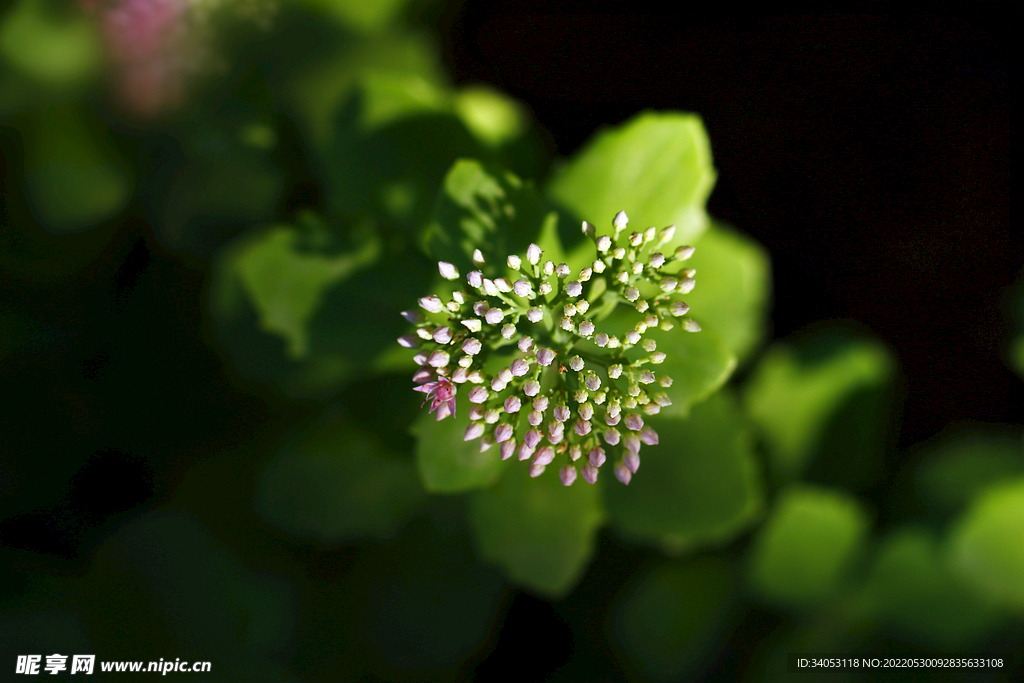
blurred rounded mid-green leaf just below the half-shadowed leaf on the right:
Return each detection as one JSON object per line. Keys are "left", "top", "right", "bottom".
{"left": 750, "top": 485, "right": 868, "bottom": 608}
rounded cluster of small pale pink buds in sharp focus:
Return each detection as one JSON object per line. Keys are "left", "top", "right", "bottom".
{"left": 398, "top": 211, "right": 700, "bottom": 486}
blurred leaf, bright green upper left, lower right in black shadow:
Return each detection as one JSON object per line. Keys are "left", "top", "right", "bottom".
{"left": 743, "top": 330, "right": 895, "bottom": 480}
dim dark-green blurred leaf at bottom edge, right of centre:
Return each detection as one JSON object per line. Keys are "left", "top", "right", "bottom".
{"left": 611, "top": 557, "right": 737, "bottom": 681}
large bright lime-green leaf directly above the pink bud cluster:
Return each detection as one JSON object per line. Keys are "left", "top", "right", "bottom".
{"left": 548, "top": 112, "right": 715, "bottom": 249}
